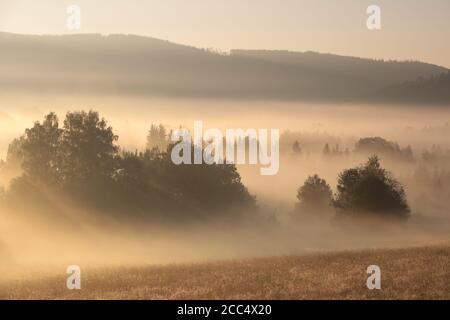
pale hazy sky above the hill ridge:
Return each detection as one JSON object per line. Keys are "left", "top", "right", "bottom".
{"left": 0, "top": 0, "right": 450, "bottom": 68}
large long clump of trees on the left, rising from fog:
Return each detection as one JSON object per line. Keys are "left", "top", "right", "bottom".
{"left": 2, "top": 111, "right": 256, "bottom": 217}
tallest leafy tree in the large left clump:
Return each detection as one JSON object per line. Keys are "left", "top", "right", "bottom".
{"left": 61, "top": 111, "right": 118, "bottom": 183}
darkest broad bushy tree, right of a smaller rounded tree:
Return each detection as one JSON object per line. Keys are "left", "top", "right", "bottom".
{"left": 333, "top": 156, "right": 410, "bottom": 219}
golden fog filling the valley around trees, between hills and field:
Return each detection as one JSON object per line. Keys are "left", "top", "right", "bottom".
{"left": 0, "top": 94, "right": 450, "bottom": 275}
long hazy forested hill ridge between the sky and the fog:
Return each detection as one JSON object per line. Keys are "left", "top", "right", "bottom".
{"left": 0, "top": 33, "right": 447, "bottom": 102}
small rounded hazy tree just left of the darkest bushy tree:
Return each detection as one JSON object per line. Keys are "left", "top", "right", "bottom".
{"left": 297, "top": 174, "right": 333, "bottom": 211}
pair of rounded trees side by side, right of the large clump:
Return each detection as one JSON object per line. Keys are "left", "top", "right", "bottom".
{"left": 296, "top": 156, "right": 410, "bottom": 220}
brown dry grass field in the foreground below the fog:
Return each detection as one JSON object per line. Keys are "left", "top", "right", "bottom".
{"left": 0, "top": 246, "right": 450, "bottom": 299}
